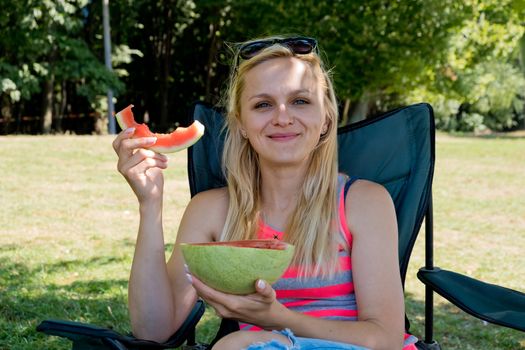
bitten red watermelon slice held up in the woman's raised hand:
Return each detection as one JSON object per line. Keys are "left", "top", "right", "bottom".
{"left": 115, "top": 105, "right": 204, "bottom": 153}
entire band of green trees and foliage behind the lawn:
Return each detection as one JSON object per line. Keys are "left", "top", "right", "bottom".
{"left": 0, "top": 0, "right": 525, "bottom": 131}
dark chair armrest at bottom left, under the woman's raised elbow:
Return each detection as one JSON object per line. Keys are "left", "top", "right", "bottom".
{"left": 36, "top": 300, "right": 205, "bottom": 349}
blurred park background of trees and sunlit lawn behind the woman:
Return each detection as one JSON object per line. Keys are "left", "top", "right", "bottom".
{"left": 0, "top": 0, "right": 525, "bottom": 350}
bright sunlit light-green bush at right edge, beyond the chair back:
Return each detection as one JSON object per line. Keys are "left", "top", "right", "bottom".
{"left": 410, "top": 61, "right": 525, "bottom": 132}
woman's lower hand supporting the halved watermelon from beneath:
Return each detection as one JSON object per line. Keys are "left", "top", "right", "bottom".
{"left": 191, "top": 275, "right": 288, "bottom": 330}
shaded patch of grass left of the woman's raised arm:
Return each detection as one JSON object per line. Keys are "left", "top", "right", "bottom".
{"left": 0, "top": 257, "right": 129, "bottom": 349}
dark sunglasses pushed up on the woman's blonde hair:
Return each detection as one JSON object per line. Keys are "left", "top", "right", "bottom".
{"left": 239, "top": 36, "right": 317, "bottom": 60}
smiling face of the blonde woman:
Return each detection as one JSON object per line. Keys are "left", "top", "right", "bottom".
{"left": 240, "top": 57, "right": 327, "bottom": 165}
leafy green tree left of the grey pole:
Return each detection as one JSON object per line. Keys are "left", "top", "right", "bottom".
{"left": 0, "top": 0, "right": 121, "bottom": 133}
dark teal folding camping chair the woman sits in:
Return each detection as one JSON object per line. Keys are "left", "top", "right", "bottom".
{"left": 37, "top": 103, "right": 525, "bottom": 350}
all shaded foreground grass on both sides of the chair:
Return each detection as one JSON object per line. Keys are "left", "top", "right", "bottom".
{"left": 0, "top": 257, "right": 525, "bottom": 350}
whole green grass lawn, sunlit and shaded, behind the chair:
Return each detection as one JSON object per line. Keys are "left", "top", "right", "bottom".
{"left": 0, "top": 134, "right": 525, "bottom": 350}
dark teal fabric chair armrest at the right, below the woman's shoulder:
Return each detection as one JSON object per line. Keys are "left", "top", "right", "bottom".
{"left": 417, "top": 268, "right": 525, "bottom": 331}
